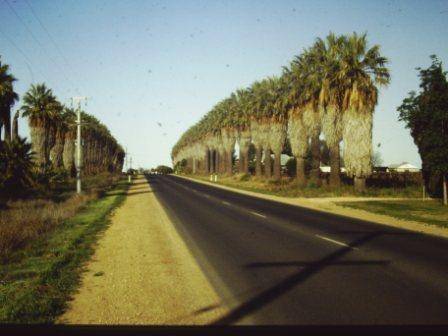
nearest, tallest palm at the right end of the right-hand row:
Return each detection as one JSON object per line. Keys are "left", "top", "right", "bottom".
{"left": 338, "top": 33, "right": 390, "bottom": 190}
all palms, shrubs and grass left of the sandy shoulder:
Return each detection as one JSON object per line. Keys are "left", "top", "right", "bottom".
{"left": 0, "top": 58, "right": 127, "bottom": 323}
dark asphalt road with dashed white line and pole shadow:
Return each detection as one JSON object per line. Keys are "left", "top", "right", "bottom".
{"left": 149, "top": 176, "right": 448, "bottom": 325}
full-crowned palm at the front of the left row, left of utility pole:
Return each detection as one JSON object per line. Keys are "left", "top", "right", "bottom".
{"left": 21, "top": 84, "right": 60, "bottom": 172}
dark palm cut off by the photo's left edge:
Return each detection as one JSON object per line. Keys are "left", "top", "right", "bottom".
{"left": 0, "top": 59, "right": 19, "bottom": 141}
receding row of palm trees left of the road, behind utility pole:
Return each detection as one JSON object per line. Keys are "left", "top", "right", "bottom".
{"left": 0, "top": 55, "right": 125, "bottom": 174}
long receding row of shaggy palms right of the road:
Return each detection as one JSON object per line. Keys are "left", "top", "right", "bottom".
{"left": 171, "top": 32, "right": 390, "bottom": 189}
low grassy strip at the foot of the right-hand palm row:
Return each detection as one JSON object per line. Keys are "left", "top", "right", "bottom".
{"left": 190, "top": 175, "right": 421, "bottom": 198}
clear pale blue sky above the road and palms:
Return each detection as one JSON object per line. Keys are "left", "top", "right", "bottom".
{"left": 0, "top": 0, "right": 448, "bottom": 168}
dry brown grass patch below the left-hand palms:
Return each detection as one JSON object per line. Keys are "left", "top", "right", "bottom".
{"left": 0, "top": 192, "right": 98, "bottom": 261}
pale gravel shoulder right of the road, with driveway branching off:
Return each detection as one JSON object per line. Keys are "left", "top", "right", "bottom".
{"left": 176, "top": 175, "right": 448, "bottom": 238}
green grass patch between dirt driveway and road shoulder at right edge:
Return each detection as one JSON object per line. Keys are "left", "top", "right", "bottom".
{"left": 337, "top": 201, "right": 448, "bottom": 228}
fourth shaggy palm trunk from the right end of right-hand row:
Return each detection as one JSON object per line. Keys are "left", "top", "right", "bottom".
{"left": 287, "top": 109, "right": 308, "bottom": 187}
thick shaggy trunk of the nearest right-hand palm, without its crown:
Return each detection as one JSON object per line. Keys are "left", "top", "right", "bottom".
{"left": 343, "top": 108, "right": 373, "bottom": 191}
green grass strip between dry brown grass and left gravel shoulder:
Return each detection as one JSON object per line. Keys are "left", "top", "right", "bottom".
{"left": 0, "top": 180, "right": 128, "bottom": 323}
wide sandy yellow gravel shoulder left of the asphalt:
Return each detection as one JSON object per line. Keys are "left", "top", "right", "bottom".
{"left": 58, "top": 177, "right": 228, "bottom": 325}
